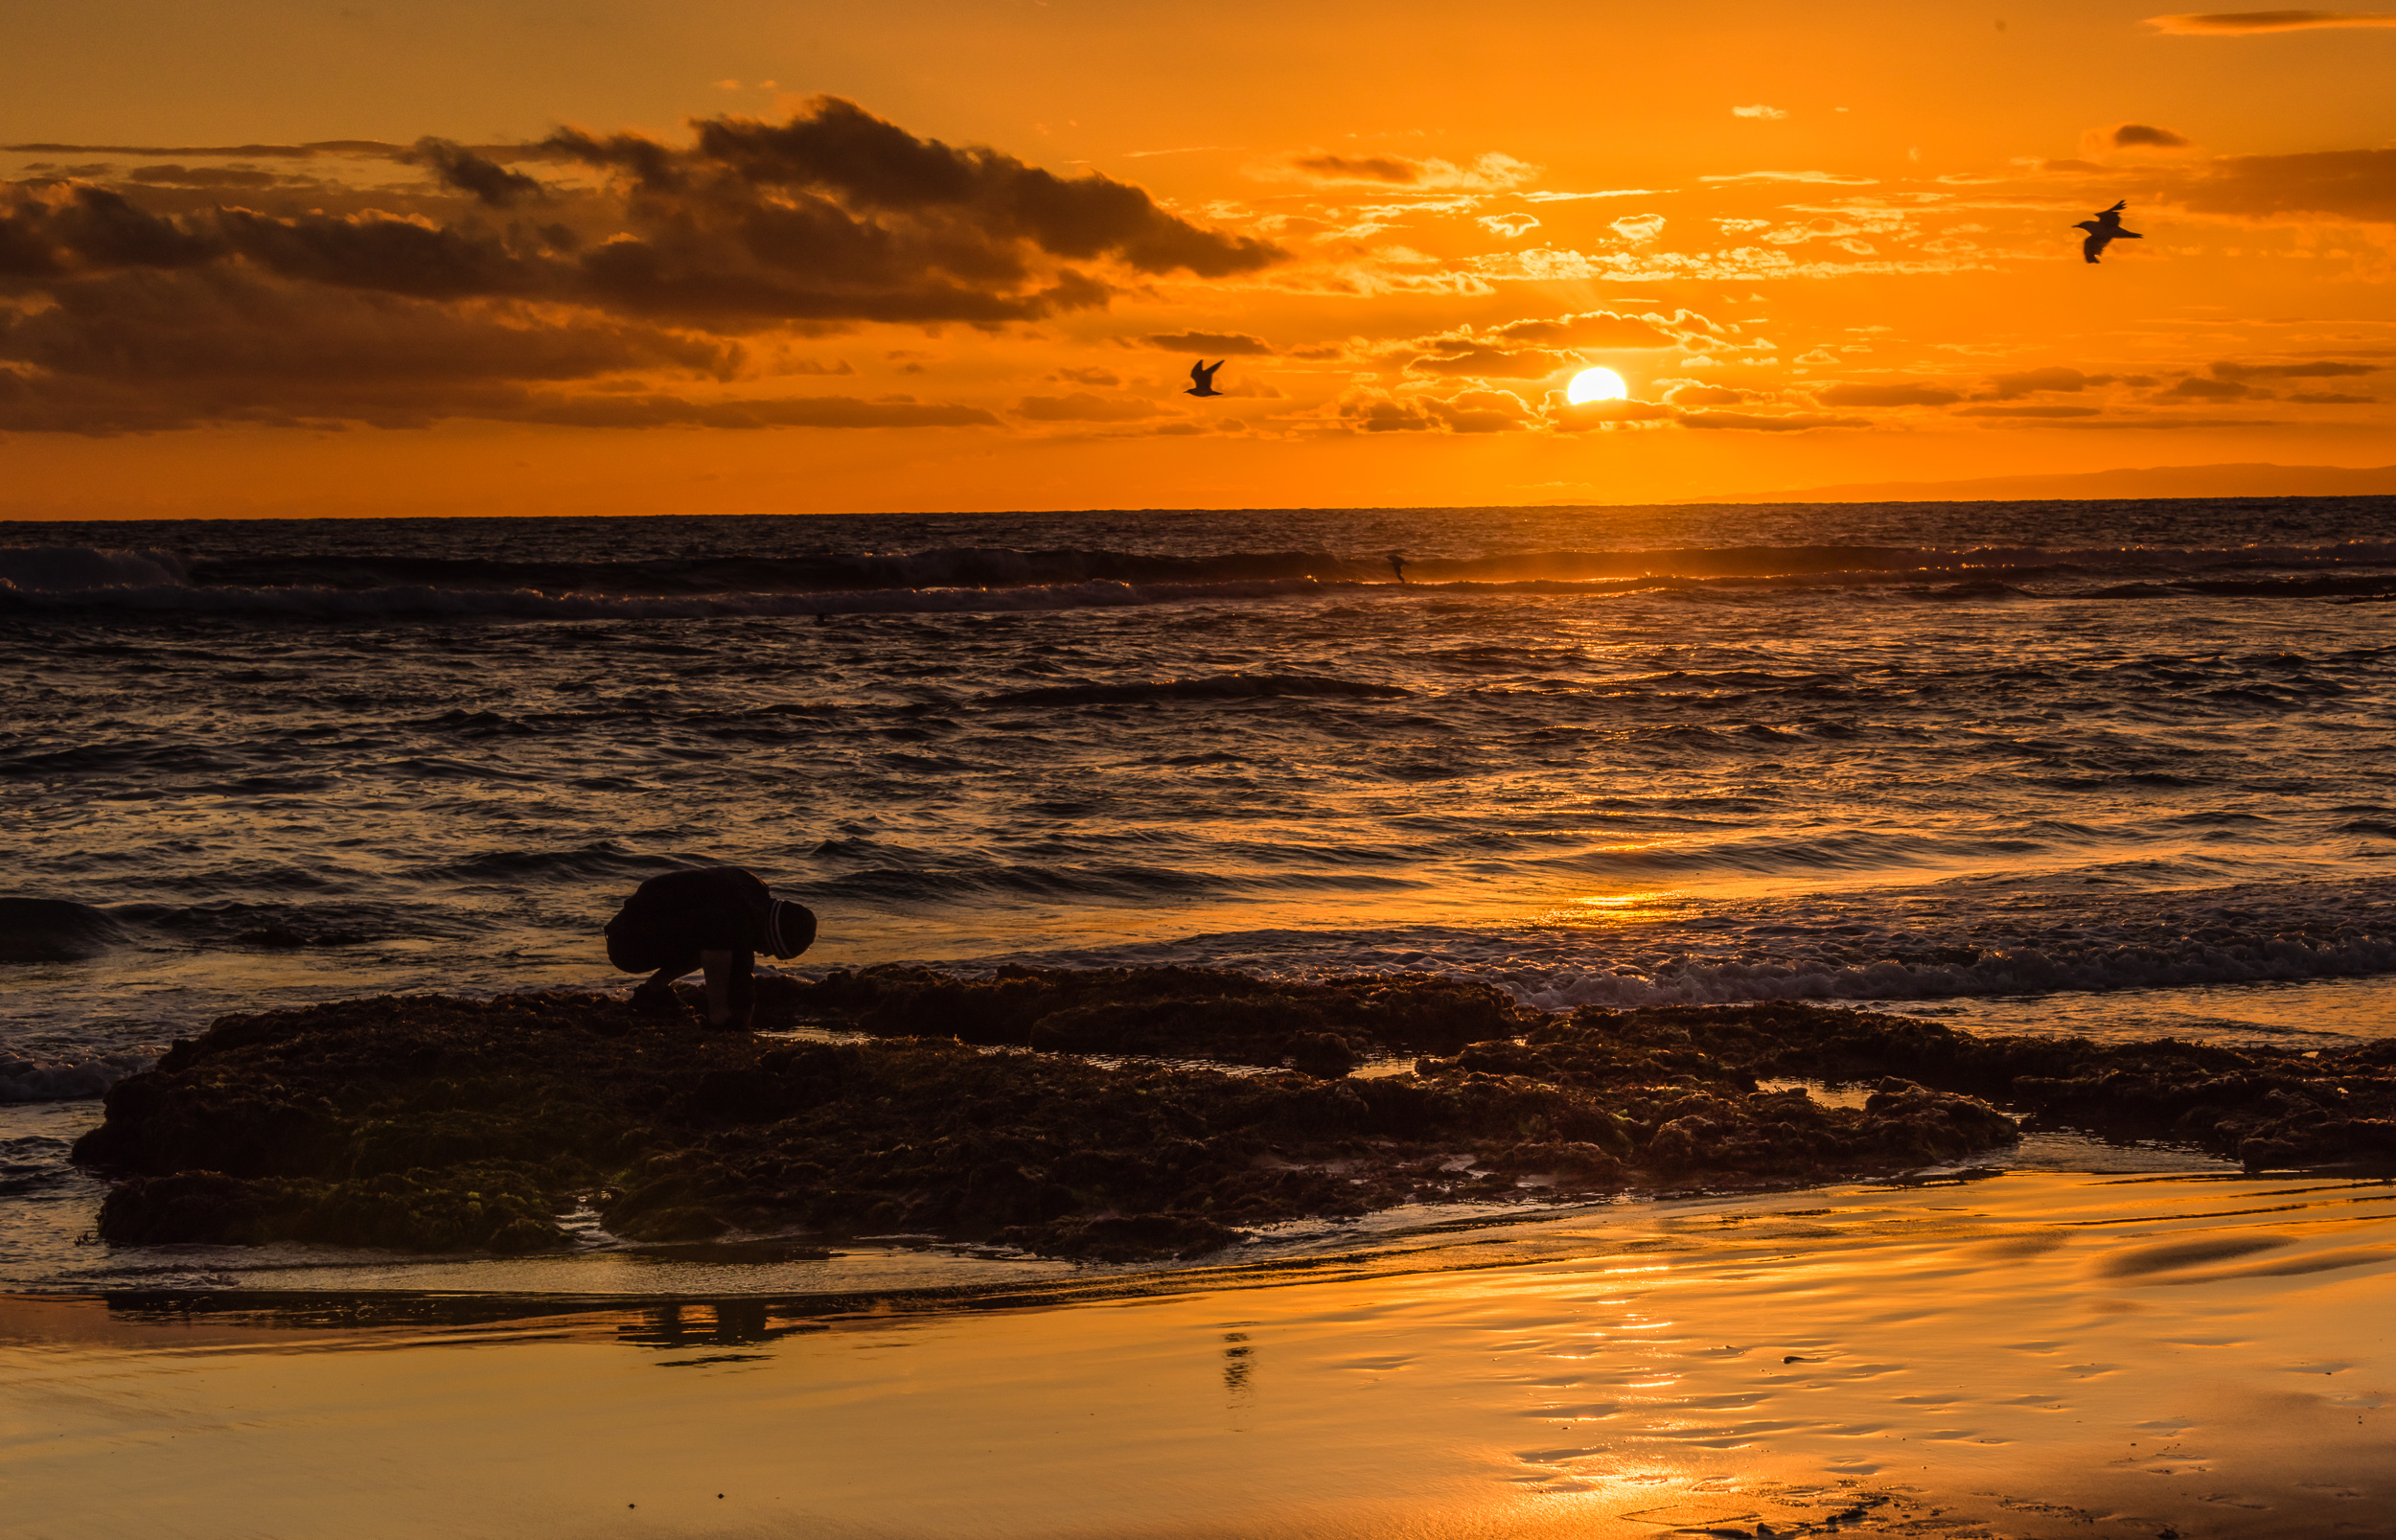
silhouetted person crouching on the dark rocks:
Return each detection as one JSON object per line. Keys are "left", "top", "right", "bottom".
{"left": 607, "top": 867, "right": 815, "bottom": 1032}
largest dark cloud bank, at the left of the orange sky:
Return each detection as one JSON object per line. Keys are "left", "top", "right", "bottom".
{"left": 0, "top": 98, "right": 1282, "bottom": 431}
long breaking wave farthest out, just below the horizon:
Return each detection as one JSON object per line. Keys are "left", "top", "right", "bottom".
{"left": 13, "top": 541, "right": 2396, "bottom": 620}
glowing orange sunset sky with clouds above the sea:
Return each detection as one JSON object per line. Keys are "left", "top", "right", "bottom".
{"left": 0, "top": 0, "right": 2396, "bottom": 517}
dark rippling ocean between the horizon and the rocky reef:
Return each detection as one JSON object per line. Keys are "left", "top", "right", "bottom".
{"left": 0, "top": 498, "right": 2396, "bottom": 1286}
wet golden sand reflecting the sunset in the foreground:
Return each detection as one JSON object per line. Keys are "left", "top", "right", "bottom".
{"left": 0, "top": 1171, "right": 2396, "bottom": 1540}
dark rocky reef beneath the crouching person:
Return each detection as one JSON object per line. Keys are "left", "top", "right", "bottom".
{"left": 77, "top": 968, "right": 2396, "bottom": 1260}
